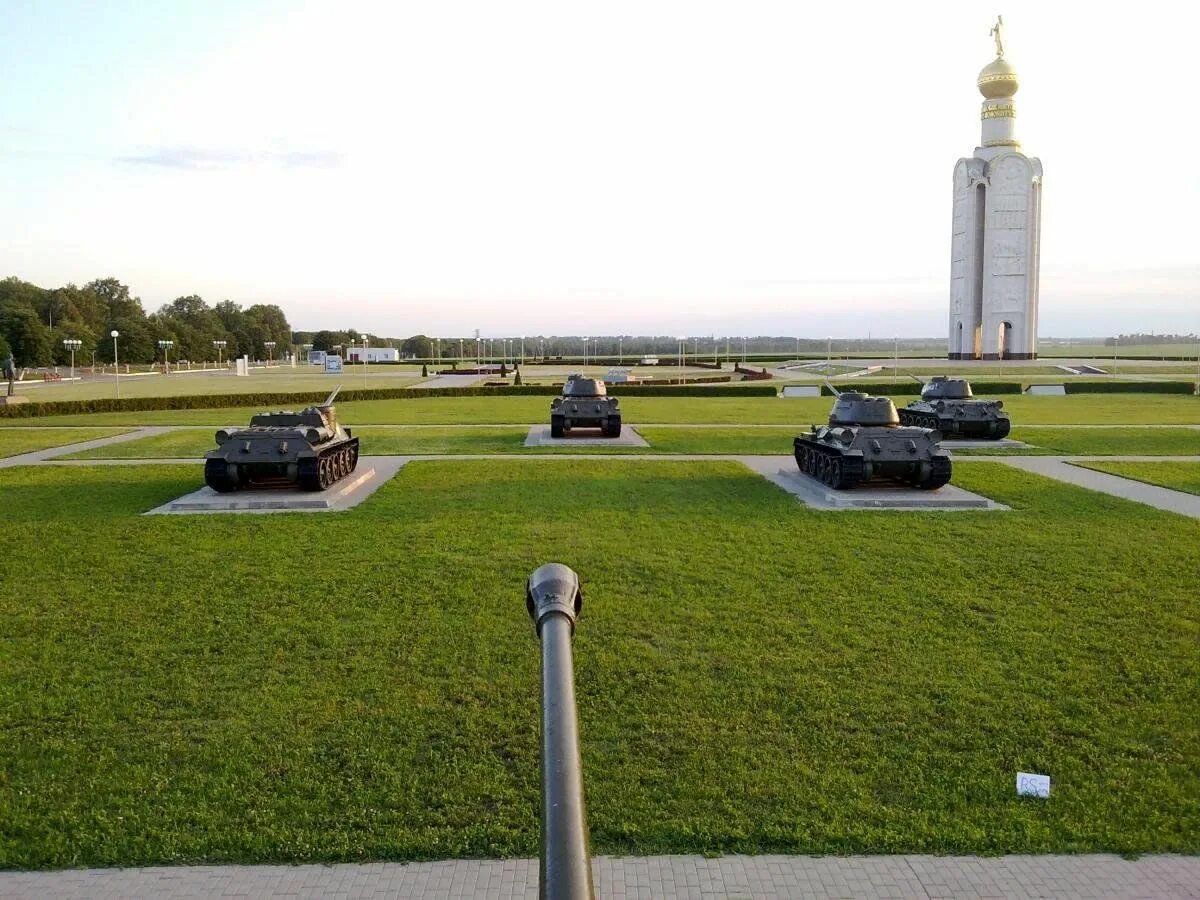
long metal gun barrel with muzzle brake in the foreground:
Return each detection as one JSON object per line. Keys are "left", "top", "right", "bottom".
{"left": 526, "top": 563, "right": 595, "bottom": 900}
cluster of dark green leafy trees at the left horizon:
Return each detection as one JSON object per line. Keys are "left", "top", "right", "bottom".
{"left": 0, "top": 277, "right": 292, "bottom": 367}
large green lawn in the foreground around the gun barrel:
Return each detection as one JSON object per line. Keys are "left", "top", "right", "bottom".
{"left": 0, "top": 460, "right": 1200, "bottom": 868}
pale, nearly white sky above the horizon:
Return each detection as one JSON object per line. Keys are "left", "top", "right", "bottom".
{"left": 0, "top": 0, "right": 1200, "bottom": 337}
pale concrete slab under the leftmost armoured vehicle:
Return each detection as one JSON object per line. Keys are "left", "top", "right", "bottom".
{"left": 145, "top": 457, "right": 408, "bottom": 516}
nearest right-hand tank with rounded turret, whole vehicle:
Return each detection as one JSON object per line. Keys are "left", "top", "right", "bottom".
{"left": 793, "top": 391, "right": 950, "bottom": 491}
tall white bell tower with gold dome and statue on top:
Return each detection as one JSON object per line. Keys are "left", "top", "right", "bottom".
{"left": 948, "top": 19, "right": 1042, "bottom": 359}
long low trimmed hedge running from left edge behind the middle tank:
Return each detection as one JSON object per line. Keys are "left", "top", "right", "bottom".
{"left": 0, "top": 384, "right": 776, "bottom": 419}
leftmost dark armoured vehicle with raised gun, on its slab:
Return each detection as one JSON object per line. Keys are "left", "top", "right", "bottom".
{"left": 204, "top": 385, "right": 359, "bottom": 493}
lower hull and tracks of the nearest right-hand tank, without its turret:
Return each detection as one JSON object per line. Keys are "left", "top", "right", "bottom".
{"left": 793, "top": 427, "right": 952, "bottom": 491}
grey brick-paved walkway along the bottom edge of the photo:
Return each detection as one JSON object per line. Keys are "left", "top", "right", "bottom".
{"left": 0, "top": 856, "right": 1200, "bottom": 900}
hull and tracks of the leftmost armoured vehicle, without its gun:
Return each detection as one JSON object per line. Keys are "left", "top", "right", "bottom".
{"left": 204, "top": 430, "right": 359, "bottom": 493}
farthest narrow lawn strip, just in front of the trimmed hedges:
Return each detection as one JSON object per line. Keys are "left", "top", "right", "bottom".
{"left": 7, "top": 390, "right": 1200, "bottom": 427}
